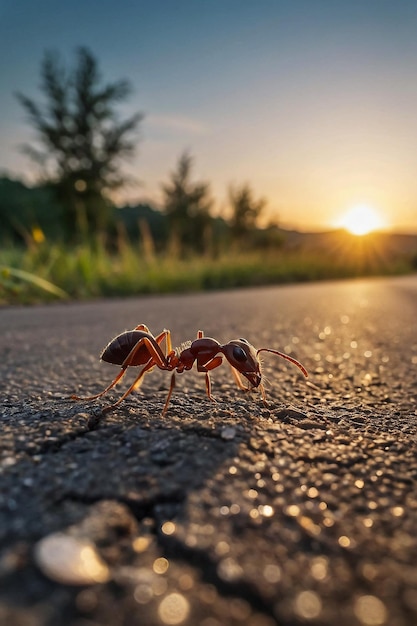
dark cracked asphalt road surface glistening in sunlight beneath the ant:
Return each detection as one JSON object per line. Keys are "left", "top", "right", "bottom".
{"left": 0, "top": 276, "right": 417, "bottom": 626}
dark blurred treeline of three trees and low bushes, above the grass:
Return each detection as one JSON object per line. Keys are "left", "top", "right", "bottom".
{"left": 0, "top": 47, "right": 280, "bottom": 257}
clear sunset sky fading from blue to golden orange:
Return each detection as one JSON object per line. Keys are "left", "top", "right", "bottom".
{"left": 0, "top": 0, "right": 417, "bottom": 232}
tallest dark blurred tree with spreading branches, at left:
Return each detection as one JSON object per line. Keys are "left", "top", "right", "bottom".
{"left": 17, "top": 47, "right": 142, "bottom": 236}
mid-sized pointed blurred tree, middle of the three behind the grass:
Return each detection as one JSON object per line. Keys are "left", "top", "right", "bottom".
{"left": 162, "top": 152, "right": 212, "bottom": 253}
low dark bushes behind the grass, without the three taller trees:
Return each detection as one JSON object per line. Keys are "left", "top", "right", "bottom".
{"left": 0, "top": 176, "right": 283, "bottom": 256}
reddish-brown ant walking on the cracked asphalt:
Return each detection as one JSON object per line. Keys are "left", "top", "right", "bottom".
{"left": 71, "top": 324, "right": 308, "bottom": 416}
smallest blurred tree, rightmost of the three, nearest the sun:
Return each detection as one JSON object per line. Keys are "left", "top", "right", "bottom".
{"left": 229, "top": 183, "right": 266, "bottom": 243}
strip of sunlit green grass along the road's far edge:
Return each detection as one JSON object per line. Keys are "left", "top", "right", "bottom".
{"left": 0, "top": 234, "right": 412, "bottom": 305}
